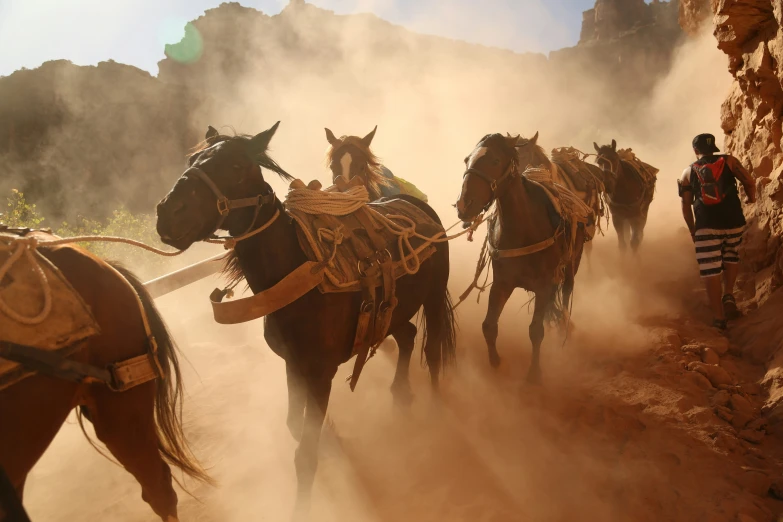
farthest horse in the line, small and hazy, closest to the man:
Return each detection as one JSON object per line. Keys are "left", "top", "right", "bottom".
{"left": 593, "top": 140, "right": 655, "bottom": 253}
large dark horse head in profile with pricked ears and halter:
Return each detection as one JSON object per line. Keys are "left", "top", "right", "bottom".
{"left": 157, "top": 122, "right": 293, "bottom": 250}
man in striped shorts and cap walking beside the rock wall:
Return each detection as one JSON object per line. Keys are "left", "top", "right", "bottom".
{"left": 677, "top": 134, "right": 756, "bottom": 330}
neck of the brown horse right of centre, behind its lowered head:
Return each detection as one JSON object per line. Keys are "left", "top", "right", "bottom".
{"left": 497, "top": 175, "right": 553, "bottom": 242}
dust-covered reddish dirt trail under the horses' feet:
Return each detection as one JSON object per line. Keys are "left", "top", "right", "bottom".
{"left": 21, "top": 232, "right": 783, "bottom": 522}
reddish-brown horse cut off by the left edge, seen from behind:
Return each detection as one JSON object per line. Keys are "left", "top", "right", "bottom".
{"left": 0, "top": 246, "right": 209, "bottom": 522}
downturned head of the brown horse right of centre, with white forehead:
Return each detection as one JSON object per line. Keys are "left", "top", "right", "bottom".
{"left": 455, "top": 134, "right": 522, "bottom": 223}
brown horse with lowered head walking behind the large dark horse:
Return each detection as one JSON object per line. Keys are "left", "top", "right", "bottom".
{"left": 456, "top": 134, "right": 584, "bottom": 383}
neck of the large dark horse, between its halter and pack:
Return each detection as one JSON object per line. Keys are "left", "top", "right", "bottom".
{"left": 235, "top": 200, "right": 307, "bottom": 293}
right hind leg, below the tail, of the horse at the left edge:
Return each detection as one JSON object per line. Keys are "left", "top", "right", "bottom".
{"left": 86, "top": 381, "right": 178, "bottom": 522}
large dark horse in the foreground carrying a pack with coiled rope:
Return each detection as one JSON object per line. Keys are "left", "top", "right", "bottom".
{"left": 157, "top": 124, "right": 455, "bottom": 512}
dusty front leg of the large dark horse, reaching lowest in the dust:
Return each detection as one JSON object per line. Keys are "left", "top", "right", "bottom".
{"left": 294, "top": 368, "right": 337, "bottom": 520}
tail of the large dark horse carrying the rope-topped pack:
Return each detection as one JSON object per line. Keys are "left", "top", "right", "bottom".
{"left": 422, "top": 243, "right": 457, "bottom": 373}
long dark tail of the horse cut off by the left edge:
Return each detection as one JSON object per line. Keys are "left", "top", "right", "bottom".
{"left": 110, "top": 263, "right": 214, "bottom": 484}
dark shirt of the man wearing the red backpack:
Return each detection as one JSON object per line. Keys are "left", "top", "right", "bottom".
{"left": 690, "top": 156, "right": 745, "bottom": 230}
